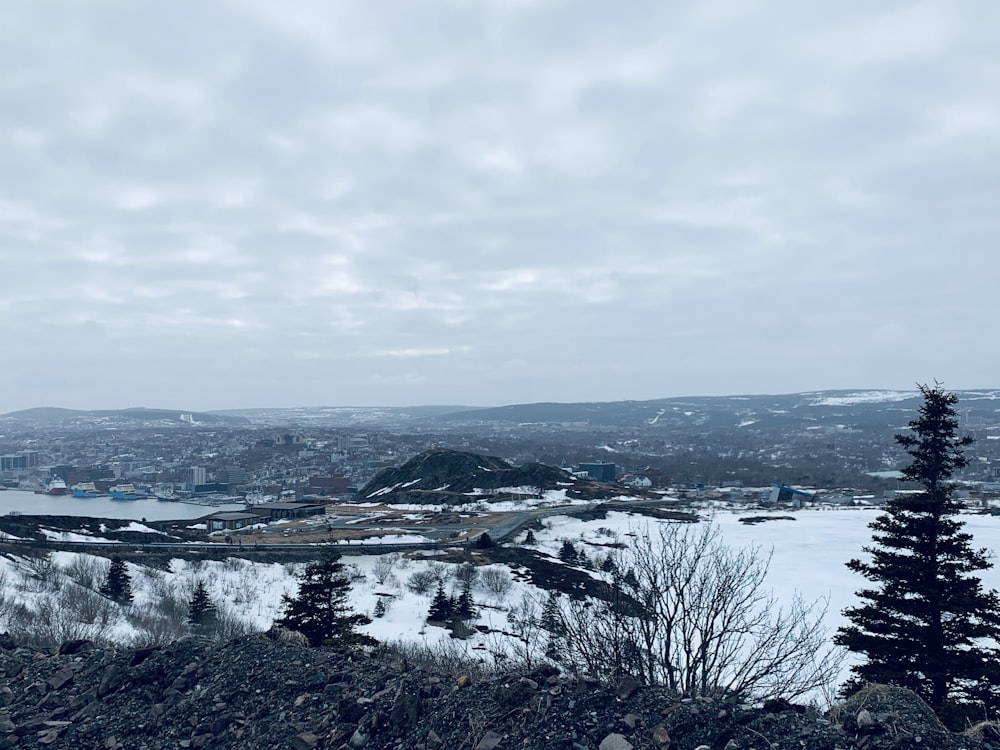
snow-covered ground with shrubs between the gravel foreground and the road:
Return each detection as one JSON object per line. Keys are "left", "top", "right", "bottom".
{"left": 0, "top": 510, "right": 1000, "bottom": 692}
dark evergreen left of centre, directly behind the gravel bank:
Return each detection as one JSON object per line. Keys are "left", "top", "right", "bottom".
{"left": 275, "top": 554, "right": 376, "bottom": 647}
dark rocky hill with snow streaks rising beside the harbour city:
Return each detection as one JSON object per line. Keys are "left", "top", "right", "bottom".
{"left": 357, "top": 448, "right": 622, "bottom": 503}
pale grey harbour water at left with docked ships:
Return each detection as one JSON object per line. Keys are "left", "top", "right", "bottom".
{"left": 0, "top": 490, "right": 244, "bottom": 521}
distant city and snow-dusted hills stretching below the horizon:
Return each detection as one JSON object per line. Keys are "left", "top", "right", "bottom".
{"left": 0, "top": 390, "right": 1000, "bottom": 516}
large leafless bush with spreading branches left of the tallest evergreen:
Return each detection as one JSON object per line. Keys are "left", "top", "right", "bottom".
{"left": 558, "top": 524, "right": 842, "bottom": 700}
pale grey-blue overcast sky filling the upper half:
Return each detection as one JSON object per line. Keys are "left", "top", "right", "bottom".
{"left": 0, "top": 0, "right": 1000, "bottom": 412}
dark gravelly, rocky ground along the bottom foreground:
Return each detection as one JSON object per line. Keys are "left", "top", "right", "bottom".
{"left": 0, "top": 635, "right": 1000, "bottom": 750}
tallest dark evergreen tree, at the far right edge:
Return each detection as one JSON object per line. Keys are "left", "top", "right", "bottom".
{"left": 834, "top": 384, "right": 1000, "bottom": 711}
